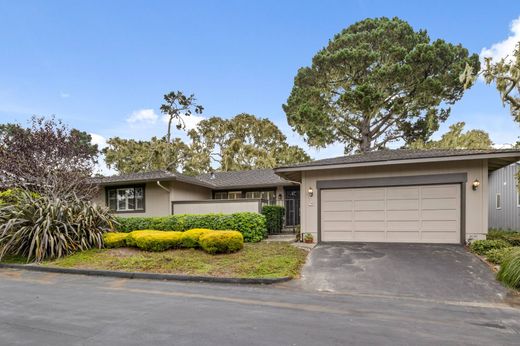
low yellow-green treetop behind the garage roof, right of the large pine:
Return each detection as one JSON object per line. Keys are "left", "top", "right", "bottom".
{"left": 409, "top": 122, "right": 493, "bottom": 149}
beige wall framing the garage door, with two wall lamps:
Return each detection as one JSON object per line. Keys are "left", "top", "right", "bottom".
{"left": 300, "top": 160, "right": 488, "bottom": 240}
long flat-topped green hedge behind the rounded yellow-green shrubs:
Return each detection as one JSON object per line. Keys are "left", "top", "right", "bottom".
{"left": 116, "top": 212, "right": 267, "bottom": 243}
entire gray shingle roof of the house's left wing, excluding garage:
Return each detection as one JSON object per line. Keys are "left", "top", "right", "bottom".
{"left": 92, "top": 169, "right": 292, "bottom": 189}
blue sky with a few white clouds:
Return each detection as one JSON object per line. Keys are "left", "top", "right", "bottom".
{"left": 0, "top": 0, "right": 520, "bottom": 173}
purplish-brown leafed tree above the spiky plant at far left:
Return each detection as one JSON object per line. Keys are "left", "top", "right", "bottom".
{"left": 0, "top": 117, "right": 98, "bottom": 199}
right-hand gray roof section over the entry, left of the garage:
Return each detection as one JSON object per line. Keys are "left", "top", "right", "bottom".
{"left": 197, "top": 169, "right": 293, "bottom": 189}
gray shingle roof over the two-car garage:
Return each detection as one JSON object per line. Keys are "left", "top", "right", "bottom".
{"left": 276, "top": 149, "right": 520, "bottom": 171}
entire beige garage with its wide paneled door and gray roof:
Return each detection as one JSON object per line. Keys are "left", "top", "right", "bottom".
{"left": 275, "top": 150, "right": 520, "bottom": 244}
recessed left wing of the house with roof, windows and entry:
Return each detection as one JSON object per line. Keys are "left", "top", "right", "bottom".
{"left": 90, "top": 169, "right": 300, "bottom": 226}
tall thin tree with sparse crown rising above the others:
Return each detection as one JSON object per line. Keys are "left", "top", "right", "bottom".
{"left": 161, "top": 91, "right": 204, "bottom": 143}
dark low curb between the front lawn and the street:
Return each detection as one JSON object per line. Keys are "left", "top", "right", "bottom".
{"left": 0, "top": 263, "right": 291, "bottom": 285}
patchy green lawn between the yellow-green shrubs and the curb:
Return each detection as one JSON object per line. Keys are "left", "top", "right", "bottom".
{"left": 42, "top": 242, "right": 307, "bottom": 278}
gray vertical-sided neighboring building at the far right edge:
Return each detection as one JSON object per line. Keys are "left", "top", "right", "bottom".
{"left": 489, "top": 162, "right": 520, "bottom": 230}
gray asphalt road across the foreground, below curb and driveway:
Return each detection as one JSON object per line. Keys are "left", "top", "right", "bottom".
{"left": 0, "top": 269, "right": 520, "bottom": 346}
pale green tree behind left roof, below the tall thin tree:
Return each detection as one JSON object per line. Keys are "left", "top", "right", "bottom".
{"left": 102, "top": 137, "right": 189, "bottom": 174}
